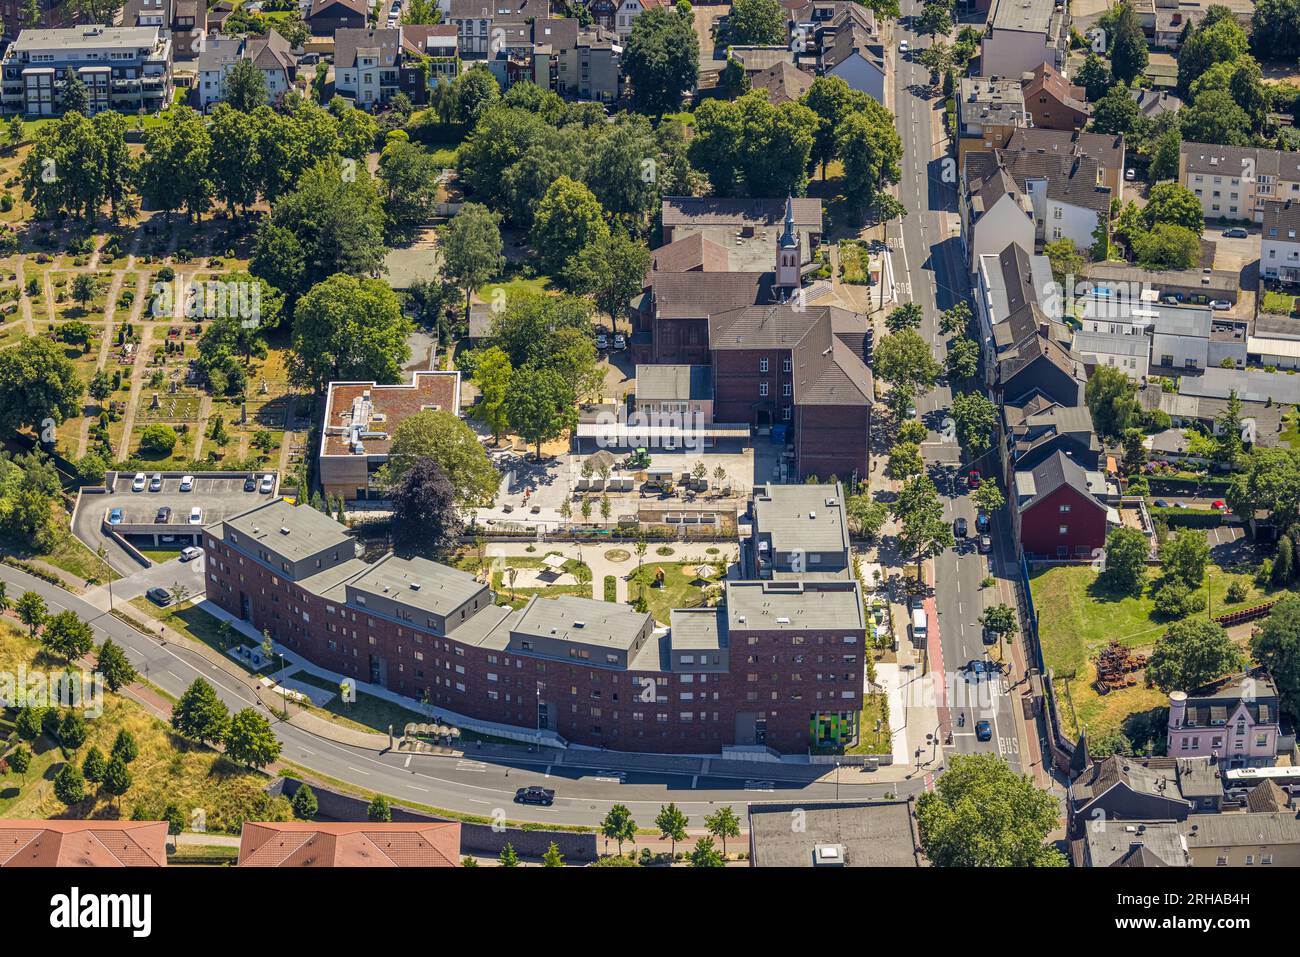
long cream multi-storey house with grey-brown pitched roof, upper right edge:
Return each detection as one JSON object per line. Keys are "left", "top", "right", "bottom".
{"left": 1178, "top": 140, "right": 1300, "bottom": 222}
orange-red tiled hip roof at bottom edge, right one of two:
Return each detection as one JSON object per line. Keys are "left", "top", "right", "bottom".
{"left": 238, "top": 820, "right": 460, "bottom": 867}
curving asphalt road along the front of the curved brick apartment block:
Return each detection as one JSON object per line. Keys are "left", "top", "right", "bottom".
{"left": 0, "top": 566, "right": 924, "bottom": 827}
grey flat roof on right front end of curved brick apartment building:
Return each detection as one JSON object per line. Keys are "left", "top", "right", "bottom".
{"left": 727, "top": 579, "right": 866, "bottom": 632}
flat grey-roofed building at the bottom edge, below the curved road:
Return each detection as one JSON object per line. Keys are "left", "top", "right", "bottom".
{"left": 749, "top": 800, "right": 926, "bottom": 867}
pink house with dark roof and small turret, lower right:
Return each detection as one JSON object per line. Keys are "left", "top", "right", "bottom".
{"left": 1167, "top": 668, "right": 1286, "bottom": 767}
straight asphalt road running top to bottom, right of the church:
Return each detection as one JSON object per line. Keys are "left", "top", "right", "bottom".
{"left": 888, "top": 0, "right": 1021, "bottom": 771}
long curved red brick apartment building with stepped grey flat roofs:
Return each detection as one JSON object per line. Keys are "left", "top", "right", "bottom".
{"left": 203, "top": 496, "right": 866, "bottom": 753}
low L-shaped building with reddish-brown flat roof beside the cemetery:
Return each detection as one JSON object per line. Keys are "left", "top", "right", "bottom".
{"left": 317, "top": 372, "right": 460, "bottom": 502}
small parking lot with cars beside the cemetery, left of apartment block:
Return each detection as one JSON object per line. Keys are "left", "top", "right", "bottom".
{"left": 73, "top": 472, "right": 280, "bottom": 575}
